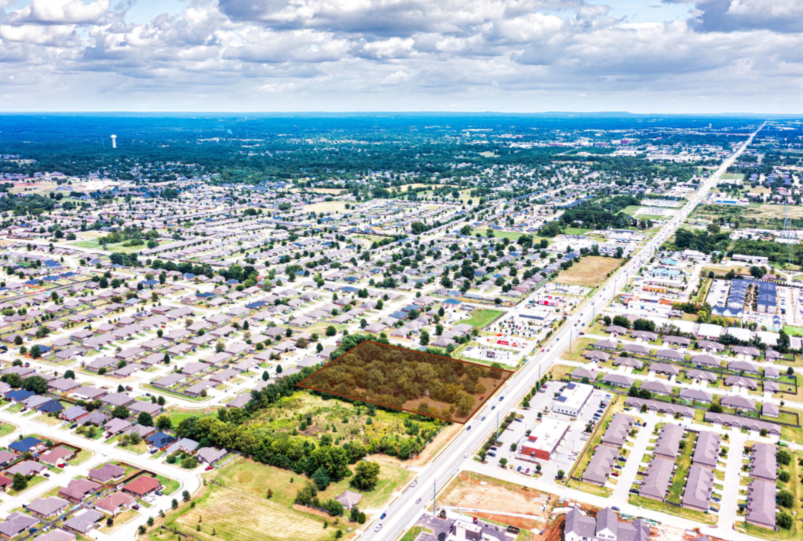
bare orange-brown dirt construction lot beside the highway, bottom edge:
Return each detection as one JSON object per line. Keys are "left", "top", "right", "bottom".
{"left": 438, "top": 472, "right": 555, "bottom": 519}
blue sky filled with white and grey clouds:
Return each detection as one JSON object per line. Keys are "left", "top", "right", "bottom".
{"left": 0, "top": 0, "right": 803, "bottom": 113}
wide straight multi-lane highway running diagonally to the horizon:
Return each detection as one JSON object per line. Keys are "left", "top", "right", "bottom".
{"left": 360, "top": 125, "right": 764, "bottom": 541}
